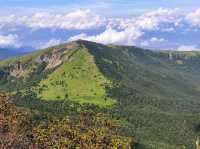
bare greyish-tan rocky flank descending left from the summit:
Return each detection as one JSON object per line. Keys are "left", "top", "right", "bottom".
{"left": 0, "top": 42, "right": 78, "bottom": 78}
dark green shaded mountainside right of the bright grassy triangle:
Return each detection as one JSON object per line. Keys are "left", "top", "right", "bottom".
{"left": 76, "top": 42, "right": 200, "bottom": 149}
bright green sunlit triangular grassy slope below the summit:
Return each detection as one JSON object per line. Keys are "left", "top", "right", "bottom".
{"left": 36, "top": 49, "right": 116, "bottom": 106}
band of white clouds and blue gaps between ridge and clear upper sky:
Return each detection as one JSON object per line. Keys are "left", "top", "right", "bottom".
{"left": 0, "top": 8, "right": 200, "bottom": 51}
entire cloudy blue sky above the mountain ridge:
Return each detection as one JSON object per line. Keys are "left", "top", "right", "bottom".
{"left": 0, "top": 0, "right": 200, "bottom": 50}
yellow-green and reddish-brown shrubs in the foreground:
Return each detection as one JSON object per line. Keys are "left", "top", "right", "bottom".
{"left": 0, "top": 93, "right": 136, "bottom": 149}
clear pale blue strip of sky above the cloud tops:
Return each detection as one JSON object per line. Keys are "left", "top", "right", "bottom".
{"left": 0, "top": 0, "right": 200, "bottom": 17}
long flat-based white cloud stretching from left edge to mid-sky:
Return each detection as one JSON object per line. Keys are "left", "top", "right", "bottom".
{"left": 0, "top": 9, "right": 106, "bottom": 29}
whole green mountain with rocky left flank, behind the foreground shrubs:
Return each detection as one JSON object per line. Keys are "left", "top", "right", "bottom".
{"left": 0, "top": 40, "right": 200, "bottom": 149}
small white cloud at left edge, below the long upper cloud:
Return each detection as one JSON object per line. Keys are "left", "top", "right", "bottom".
{"left": 0, "top": 34, "right": 20, "bottom": 47}
